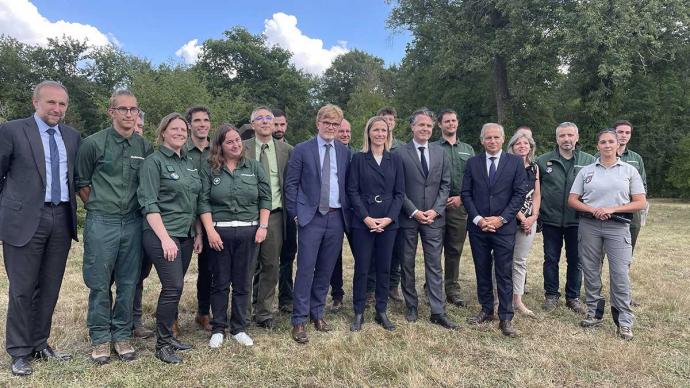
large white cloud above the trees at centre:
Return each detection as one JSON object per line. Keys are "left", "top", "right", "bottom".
{"left": 263, "top": 12, "right": 349, "bottom": 74}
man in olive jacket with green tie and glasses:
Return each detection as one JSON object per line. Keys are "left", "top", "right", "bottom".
{"left": 244, "top": 106, "right": 292, "bottom": 329}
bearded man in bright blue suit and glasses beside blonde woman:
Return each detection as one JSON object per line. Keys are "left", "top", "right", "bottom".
{"left": 284, "top": 104, "right": 350, "bottom": 343}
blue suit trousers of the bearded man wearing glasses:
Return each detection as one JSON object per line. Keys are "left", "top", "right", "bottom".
{"left": 292, "top": 210, "right": 345, "bottom": 326}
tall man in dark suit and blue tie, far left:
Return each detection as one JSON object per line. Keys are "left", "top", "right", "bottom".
{"left": 0, "top": 81, "right": 80, "bottom": 376}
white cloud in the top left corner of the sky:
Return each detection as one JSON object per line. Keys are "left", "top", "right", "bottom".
{"left": 0, "top": 0, "right": 114, "bottom": 46}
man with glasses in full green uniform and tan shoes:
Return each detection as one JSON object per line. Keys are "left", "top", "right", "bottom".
{"left": 76, "top": 90, "right": 152, "bottom": 363}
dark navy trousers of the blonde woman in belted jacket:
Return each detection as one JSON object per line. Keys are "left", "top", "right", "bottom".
{"left": 351, "top": 229, "right": 398, "bottom": 314}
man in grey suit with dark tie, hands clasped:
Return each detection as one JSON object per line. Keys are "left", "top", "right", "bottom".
{"left": 397, "top": 109, "right": 457, "bottom": 329}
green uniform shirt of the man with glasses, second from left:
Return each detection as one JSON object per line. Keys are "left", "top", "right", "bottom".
{"left": 75, "top": 128, "right": 153, "bottom": 215}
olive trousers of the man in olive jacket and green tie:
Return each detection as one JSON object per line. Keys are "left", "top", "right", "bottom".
{"left": 252, "top": 210, "right": 283, "bottom": 322}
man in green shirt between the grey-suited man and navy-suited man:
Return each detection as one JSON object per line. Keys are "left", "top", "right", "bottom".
{"left": 436, "top": 109, "right": 474, "bottom": 307}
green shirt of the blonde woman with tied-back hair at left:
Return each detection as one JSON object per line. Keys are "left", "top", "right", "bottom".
{"left": 137, "top": 145, "right": 201, "bottom": 237}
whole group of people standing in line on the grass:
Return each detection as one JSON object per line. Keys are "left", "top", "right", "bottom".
{"left": 0, "top": 81, "right": 646, "bottom": 375}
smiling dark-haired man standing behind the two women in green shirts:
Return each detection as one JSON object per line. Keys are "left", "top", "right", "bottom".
{"left": 185, "top": 106, "right": 211, "bottom": 331}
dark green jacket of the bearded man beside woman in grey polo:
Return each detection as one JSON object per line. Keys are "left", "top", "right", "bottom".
{"left": 537, "top": 147, "right": 594, "bottom": 228}
